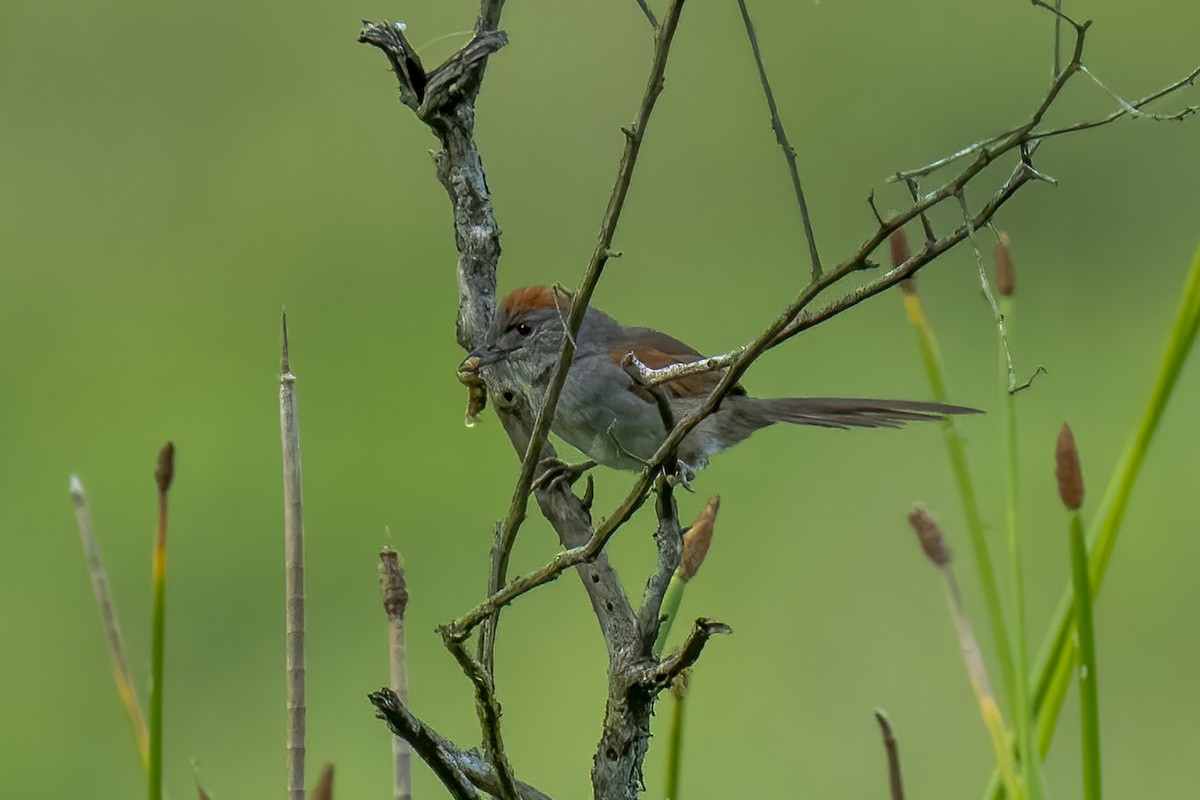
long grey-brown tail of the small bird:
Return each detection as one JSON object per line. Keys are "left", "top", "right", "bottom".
{"left": 743, "top": 397, "right": 983, "bottom": 428}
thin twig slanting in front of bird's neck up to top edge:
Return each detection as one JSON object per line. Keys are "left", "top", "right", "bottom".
{"left": 480, "top": 0, "right": 683, "bottom": 672}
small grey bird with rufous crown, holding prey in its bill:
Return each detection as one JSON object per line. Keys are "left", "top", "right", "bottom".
{"left": 460, "top": 287, "right": 979, "bottom": 485}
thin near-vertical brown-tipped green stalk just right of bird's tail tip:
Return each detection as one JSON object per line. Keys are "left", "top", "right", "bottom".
{"left": 996, "top": 293, "right": 1045, "bottom": 800}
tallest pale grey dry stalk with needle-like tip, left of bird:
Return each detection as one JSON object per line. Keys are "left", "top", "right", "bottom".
{"left": 280, "top": 314, "right": 305, "bottom": 800}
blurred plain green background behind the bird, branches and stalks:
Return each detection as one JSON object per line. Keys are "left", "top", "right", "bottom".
{"left": 0, "top": 0, "right": 1200, "bottom": 799}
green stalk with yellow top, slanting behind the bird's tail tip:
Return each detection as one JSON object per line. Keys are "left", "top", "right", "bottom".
{"left": 904, "top": 284, "right": 1024, "bottom": 738}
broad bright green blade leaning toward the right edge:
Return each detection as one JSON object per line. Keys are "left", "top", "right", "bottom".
{"left": 985, "top": 244, "right": 1200, "bottom": 799}
